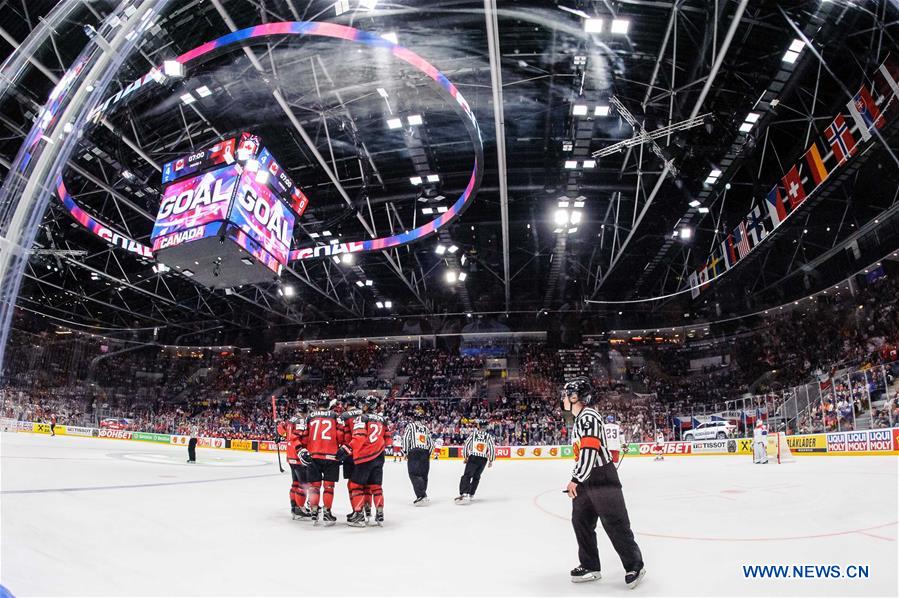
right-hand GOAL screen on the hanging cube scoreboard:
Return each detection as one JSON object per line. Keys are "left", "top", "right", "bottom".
{"left": 228, "top": 170, "right": 296, "bottom": 265}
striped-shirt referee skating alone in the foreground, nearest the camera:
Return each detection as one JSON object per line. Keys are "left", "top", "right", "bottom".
{"left": 562, "top": 377, "right": 646, "bottom": 588}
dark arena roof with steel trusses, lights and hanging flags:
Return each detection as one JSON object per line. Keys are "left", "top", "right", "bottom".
{"left": 0, "top": 0, "right": 899, "bottom": 346}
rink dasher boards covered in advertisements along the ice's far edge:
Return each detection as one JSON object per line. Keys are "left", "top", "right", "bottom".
{"left": 7, "top": 419, "right": 899, "bottom": 461}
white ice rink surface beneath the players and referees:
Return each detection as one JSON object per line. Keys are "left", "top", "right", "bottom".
{"left": 0, "top": 433, "right": 899, "bottom": 596}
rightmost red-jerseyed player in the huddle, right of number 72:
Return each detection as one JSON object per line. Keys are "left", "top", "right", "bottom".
{"left": 347, "top": 396, "right": 393, "bottom": 527}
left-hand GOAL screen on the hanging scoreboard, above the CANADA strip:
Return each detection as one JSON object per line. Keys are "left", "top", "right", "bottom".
{"left": 150, "top": 164, "right": 242, "bottom": 239}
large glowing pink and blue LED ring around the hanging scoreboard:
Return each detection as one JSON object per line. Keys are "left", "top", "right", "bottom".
{"left": 65, "top": 21, "right": 484, "bottom": 261}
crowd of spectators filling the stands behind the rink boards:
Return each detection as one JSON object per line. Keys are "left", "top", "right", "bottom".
{"left": 0, "top": 277, "right": 899, "bottom": 445}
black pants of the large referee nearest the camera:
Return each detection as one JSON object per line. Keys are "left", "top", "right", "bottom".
{"left": 571, "top": 463, "right": 643, "bottom": 571}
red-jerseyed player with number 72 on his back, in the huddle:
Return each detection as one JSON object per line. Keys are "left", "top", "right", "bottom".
{"left": 299, "top": 393, "right": 345, "bottom": 525}
